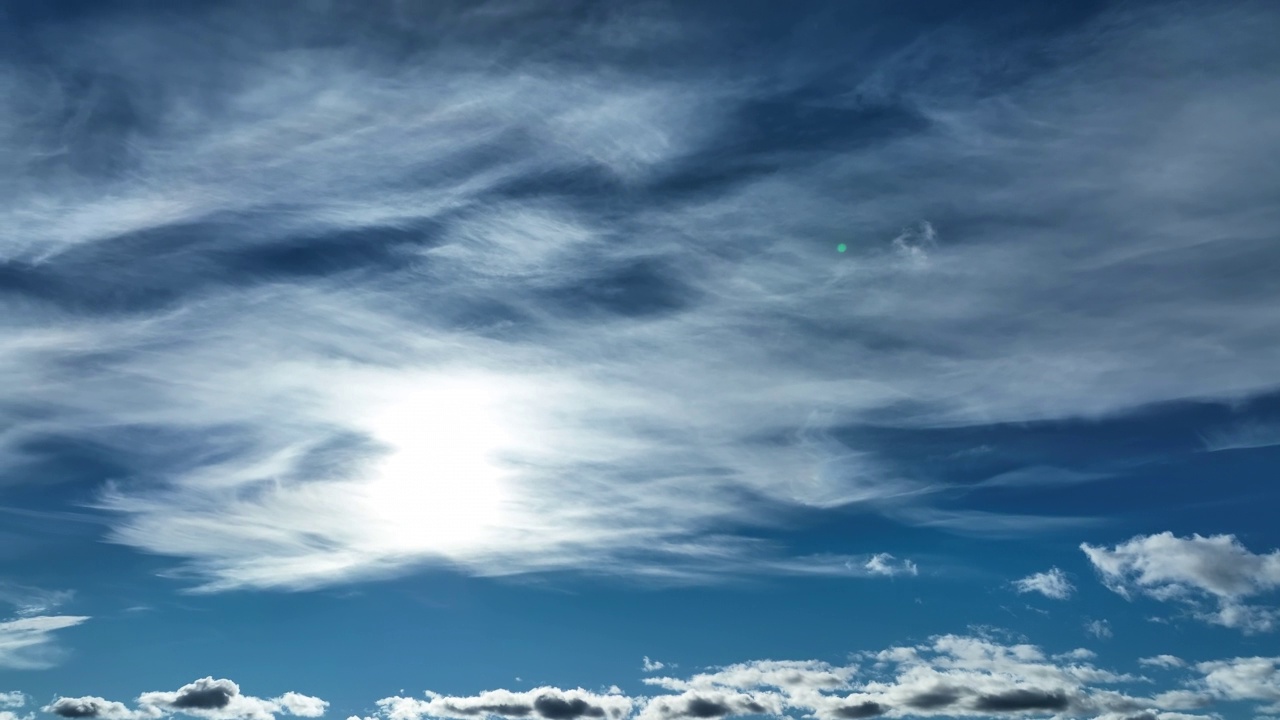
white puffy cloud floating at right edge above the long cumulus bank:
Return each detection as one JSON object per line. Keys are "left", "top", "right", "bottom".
{"left": 1080, "top": 532, "right": 1280, "bottom": 633}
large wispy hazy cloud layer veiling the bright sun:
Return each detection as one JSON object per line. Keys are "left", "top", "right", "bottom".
{"left": 0, "top": 3, "right": 1280, "bottom": 589}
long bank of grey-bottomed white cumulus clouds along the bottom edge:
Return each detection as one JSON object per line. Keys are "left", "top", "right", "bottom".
{"left": 366, "top": 635, "right": 1275, "bottom": 720}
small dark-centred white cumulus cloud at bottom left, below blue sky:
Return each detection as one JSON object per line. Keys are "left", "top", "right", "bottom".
{"left": 44, "top": 676, "right": 329, "bottom": 720}
